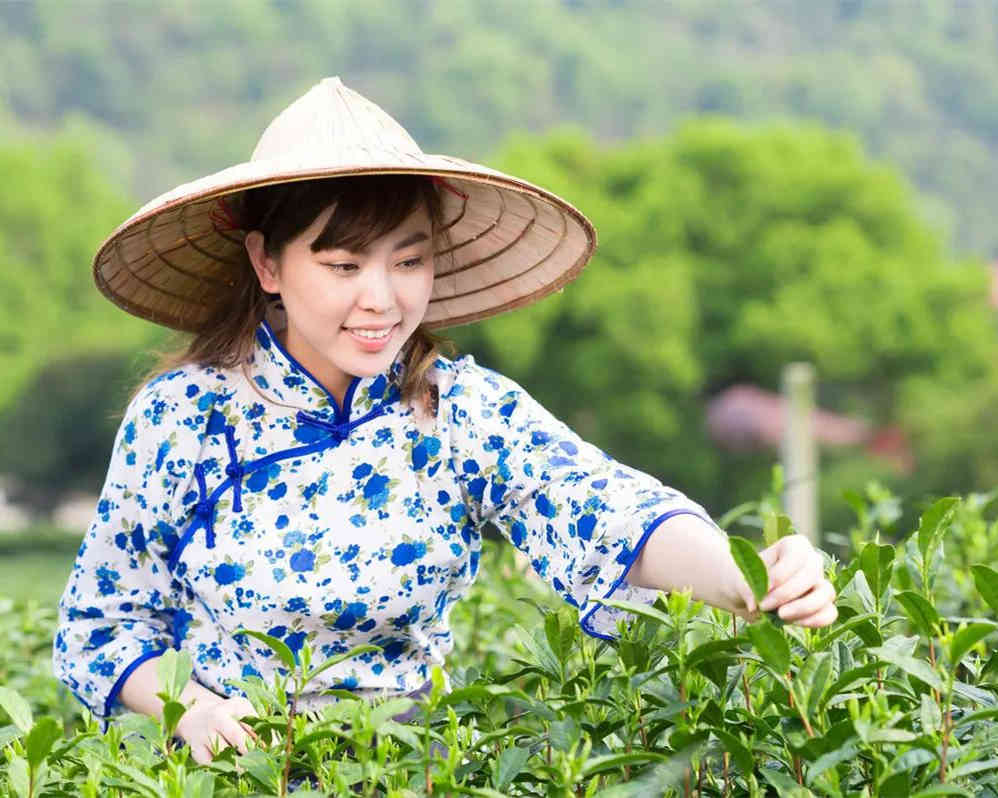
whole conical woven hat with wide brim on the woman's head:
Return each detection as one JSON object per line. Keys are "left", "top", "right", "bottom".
{"left": 94, "top": 78, "right": 596, "bottom": 331}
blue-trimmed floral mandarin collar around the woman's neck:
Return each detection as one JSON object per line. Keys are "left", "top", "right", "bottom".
{"left": 248, "top": 306, "right": 409, "bottom": 423}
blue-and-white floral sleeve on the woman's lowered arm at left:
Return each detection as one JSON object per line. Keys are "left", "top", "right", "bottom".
{"left": 52, "top": 378, "right": 195, "bottom": 718}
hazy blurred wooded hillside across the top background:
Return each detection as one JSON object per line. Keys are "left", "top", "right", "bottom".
{"left": 0, "top": 0, "right": 998, "bottom": 257}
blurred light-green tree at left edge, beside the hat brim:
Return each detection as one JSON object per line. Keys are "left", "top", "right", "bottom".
{"left": 0, "top": 127, "right": 159, "bottom": 411}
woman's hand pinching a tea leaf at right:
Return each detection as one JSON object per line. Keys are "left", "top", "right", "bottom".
{"left": 735, "top": 535, "right": 839, "bottom": 627}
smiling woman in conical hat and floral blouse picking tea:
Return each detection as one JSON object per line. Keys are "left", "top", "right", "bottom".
{"left": 54, "top": 78, "right": 836, "bottom": 762}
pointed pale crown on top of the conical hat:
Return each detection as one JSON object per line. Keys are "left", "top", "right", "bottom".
{"left": 250, "top": 77, "right": 423, "bottom": 163}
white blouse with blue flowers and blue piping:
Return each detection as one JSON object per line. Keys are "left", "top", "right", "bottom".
{"left": 53, "top": 310, "right": 716, "bottom": 718}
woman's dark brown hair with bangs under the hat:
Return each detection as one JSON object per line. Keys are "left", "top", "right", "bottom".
{"left": 139, "top": 174, "right": 453, "bottom": 410}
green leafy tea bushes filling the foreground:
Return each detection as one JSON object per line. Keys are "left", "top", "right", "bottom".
{"left": 0, "top": 486, "right": 998, "bottom": 798}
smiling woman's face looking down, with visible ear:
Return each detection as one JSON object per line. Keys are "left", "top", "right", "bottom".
{"left": 246, "top": 206, "right": 433, "bottom": 404}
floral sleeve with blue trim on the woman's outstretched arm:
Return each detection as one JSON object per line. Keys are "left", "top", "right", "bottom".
{"left": 443, "top": 356, "right": 724, "bottom": 639}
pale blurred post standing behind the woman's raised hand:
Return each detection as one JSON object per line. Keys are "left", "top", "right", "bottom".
{"left": 782, "top": 363, "right": 821, "bottom": 546}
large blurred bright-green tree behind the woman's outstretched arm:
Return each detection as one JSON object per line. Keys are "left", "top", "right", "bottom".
{"left": 454, "top": 119, "right": 998, "bottom": 511}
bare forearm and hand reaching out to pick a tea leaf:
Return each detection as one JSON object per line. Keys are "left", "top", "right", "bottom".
{"left": 627, "top": 514, "right": 838, "bottom": 626}
